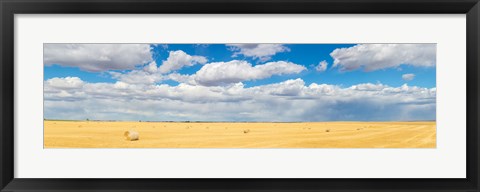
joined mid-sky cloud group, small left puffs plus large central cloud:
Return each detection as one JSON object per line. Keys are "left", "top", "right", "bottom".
{"left": 109, "top": 51, "right": 306, "bottom": 86}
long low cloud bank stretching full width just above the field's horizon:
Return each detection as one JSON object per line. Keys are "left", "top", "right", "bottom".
{"left": 44, "top": 77, "right": 436, "bottom": 121}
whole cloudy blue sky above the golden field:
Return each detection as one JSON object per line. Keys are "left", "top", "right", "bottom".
{"left": 44, "top": 44, "right": 436, "bottom": 121}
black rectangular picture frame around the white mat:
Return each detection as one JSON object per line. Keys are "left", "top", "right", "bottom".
{"left": 0, "top": 0, "right": 480, "bottom": 192}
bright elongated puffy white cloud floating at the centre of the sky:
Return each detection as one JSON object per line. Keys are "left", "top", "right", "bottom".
{"left": 193, "top": 60, "right": 305, "bottom": 86}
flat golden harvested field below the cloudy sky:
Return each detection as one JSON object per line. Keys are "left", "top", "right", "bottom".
{"left": 44, "top": 120, "right": 436, "bottom": 148}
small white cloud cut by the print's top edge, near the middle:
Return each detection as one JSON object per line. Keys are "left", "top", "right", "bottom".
{"left": 226, "top": 44, "right": 290, "bottom": 62}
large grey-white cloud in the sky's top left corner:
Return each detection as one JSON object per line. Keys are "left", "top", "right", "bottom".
{"left": 43, "top": 44, "right": 152, "bottom": 72}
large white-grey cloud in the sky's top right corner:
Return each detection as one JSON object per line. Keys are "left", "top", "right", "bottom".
{"left": 330, "top": 44, "right": 436, "bottom": 71}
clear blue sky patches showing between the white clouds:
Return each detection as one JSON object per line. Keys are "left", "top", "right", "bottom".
{"left": 44, "top": 44, "right": 436, "bottom": 88}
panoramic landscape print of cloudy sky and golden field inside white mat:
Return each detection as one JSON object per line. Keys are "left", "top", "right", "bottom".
{"left": 43, "top": 43, "right": 436, "bottom": 148}
